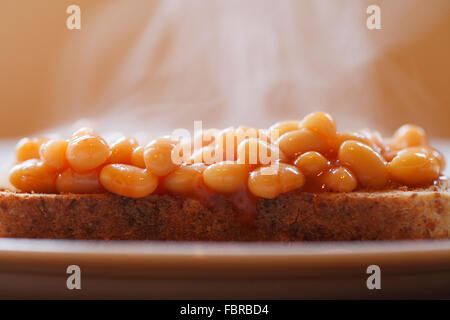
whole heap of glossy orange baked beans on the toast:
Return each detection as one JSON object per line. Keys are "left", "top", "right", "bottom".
{"left": 10, "top": 112, "right": 445, "bottom": 198}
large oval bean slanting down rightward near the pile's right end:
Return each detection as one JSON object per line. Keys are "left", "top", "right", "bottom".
{"left": 338, "top": 140, "right": 389, "bottom": 188}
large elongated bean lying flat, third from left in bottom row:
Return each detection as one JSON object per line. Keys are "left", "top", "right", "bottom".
{"left": 100, "top": 164, "right": 158, "bottom": 198}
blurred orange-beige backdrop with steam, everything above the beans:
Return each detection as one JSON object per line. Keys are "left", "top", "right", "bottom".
{"left": 0, "top": 0, "right": 450, "bottom": 138}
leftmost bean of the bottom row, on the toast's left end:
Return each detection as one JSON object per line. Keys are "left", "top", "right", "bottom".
{"left": 9, "top": 159, "right": 57, "bottom": 193}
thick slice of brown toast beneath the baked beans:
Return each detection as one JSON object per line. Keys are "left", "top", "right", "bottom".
{"left": 0, "top": 182, "right": 450, "bottom": 241}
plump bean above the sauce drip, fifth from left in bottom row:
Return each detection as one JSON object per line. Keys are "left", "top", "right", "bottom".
{"left": 203, "top": 161, "right": 248, "bottom": 193}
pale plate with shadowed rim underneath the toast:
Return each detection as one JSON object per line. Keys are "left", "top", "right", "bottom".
{"left": 0, "top": 239, "right": 450, "bottom": 299}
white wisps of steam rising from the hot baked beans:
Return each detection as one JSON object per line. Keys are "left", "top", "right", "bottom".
{"left": 0, "top": 0, "right": 449, "bottom": 188}
